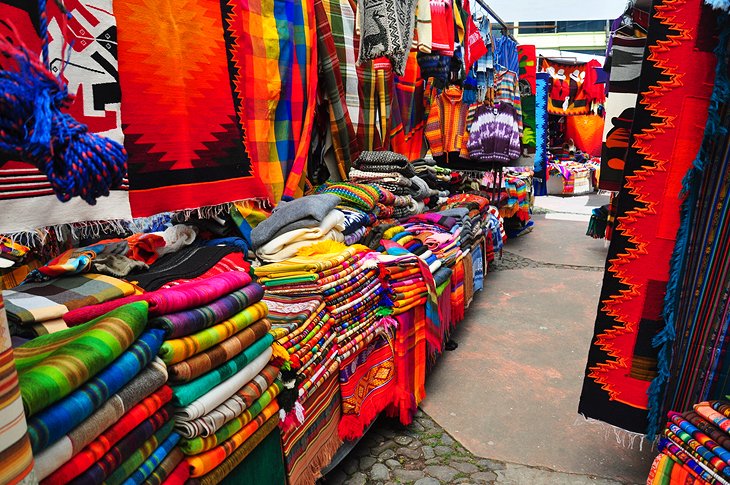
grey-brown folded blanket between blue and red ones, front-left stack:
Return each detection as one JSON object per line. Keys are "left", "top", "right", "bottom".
{"left": 35, "top": 358, "right": 172, "bottom": 483}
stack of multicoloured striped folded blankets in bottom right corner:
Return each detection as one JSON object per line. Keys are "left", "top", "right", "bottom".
{"left": 646, "top": 401, "right": 730, "bottom": 485}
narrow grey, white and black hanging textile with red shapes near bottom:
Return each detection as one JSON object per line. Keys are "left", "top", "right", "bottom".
{"left": 598, "top": 33, "right": 646, "bottom": 191}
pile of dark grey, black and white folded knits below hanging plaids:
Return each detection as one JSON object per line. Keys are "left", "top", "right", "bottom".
{"left": 349, "top": 151, "right": 432, "bottom": 218}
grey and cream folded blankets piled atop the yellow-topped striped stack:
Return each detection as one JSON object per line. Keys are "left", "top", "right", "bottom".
{"left": 251, "top": 193, "right": 345, "bottom": 262}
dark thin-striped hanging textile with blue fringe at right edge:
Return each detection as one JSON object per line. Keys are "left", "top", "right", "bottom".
{"left": 649, "top": 14, "right": 730, "bottom": 434}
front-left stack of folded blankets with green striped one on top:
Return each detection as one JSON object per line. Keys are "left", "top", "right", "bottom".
{"left": 15, "top": 301, "right": 179, "bottom": 484}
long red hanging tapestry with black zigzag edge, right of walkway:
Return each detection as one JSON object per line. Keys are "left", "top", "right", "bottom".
{"left": 579, "top": 0, "right": 715, "bottom": 433}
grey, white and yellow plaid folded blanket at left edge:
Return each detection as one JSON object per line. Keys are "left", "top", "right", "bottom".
{"left": 3, "top": 274, "right": 135, "bottom": 325}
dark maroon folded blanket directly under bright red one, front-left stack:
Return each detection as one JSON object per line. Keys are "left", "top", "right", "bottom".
{"left": 70, "top": 404, "right": 175, "bottom": 485}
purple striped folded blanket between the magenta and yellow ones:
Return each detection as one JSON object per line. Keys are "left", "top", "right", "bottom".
{"left": 149, "top": 283, "right": 264, "bottom": 339}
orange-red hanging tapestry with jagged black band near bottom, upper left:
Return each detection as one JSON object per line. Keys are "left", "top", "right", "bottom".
{"left": 114, "top": 0, "right": 268, "bottom": 217}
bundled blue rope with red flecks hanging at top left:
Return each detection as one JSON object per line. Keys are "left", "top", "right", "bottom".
{"left": 0, "top": 0, "right": 127, "bottom": 205}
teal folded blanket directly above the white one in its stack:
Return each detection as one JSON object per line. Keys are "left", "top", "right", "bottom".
{"left": 172, "top": 334, "right": 274, "bottom": 407}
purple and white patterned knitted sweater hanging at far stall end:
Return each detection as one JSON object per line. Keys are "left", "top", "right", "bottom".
{"left": 467, "top": 103, "right": 520, "bottom": 163}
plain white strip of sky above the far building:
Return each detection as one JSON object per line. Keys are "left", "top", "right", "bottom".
{"left": 486, "top": 0, "right": 628, "bottom": 22}
